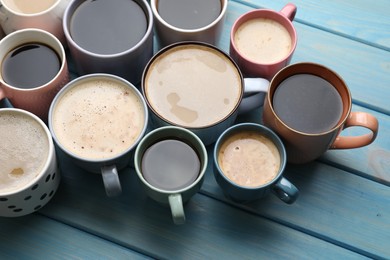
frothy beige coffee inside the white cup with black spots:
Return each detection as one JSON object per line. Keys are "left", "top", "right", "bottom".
{"left": 0, "top": 112, "right": 49, "bottom": 193}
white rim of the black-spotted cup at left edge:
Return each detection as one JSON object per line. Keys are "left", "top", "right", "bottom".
{"left": 0, "top": 107, "right": 55, "bottom": 197}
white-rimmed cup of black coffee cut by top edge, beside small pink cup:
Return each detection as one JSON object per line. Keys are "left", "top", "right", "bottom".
{"left": 150, "top": 0, "right": 228, "bottom": 47}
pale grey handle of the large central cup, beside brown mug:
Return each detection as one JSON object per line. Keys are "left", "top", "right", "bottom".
{"left": 238, "top": 78, "right": 269, "bottom": 114}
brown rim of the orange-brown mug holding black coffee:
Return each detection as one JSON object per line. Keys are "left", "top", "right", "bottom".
{"left": 266, "top": 62, "right": 352, "bottom": 137}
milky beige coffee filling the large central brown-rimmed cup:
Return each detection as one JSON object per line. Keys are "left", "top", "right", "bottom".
{"left": 144, "top": 44, "right": 243, "bottom": 128}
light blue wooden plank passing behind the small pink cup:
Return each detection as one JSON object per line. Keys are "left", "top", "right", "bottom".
{"left": 218, "top": 1, "right": 390, "bottom": 115}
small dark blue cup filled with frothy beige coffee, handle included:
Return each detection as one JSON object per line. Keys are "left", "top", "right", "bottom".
{"left": 213, "top": 123, "right": 299, "bottom": 204}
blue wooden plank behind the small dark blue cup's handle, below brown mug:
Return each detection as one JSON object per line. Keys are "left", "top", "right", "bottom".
{"left": 202, "top": 155, "right": 390, "bottom": 258}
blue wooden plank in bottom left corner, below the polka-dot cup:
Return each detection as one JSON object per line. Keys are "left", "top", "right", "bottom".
{"left": 0, "top": 214, "right": 147, "bottom": 259}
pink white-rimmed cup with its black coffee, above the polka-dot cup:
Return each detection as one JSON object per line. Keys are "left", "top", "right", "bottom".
{"left": 0, "top": 28, "right": 69, "bottom": 122}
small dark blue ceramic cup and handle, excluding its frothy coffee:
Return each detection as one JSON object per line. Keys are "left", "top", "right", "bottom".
{"left": 213, "top": 123, "right": 299, "bottom": 204}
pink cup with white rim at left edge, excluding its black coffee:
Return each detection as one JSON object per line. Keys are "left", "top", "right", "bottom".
{"left": 0, "top": 29, "right": 69, "bottom": 122}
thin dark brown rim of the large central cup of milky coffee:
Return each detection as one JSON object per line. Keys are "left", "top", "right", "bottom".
{"left": 141, "top": 41, "right": 245, "bottom": 130}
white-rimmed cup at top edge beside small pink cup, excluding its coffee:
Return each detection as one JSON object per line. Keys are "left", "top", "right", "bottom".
{"left": 150, "top": 0, "right": 228, "bottom": 47}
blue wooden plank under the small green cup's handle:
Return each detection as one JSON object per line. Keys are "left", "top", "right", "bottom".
{"left": 36, "top": 152, "right": 361, "bottom": 259}
